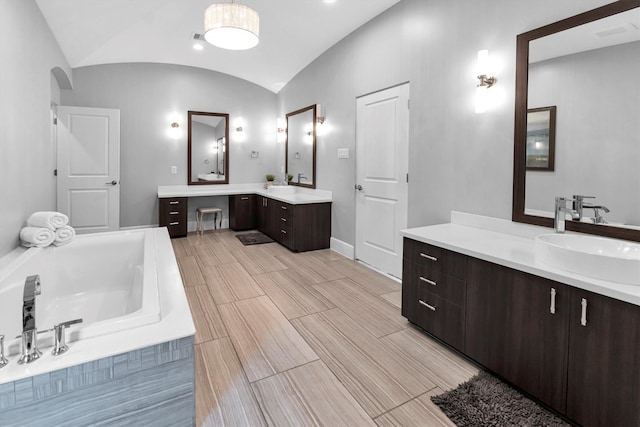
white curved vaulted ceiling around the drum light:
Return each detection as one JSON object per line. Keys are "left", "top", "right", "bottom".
{"left": 36, "top": 0, "right": 400, "bottom": 93}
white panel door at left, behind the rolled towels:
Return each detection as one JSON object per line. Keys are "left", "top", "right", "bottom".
{"left": 56, "top": 106, "right": 120, "bottom": 233}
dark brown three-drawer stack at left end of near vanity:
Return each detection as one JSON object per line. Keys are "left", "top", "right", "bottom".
{"left": 402, "top": 239, "right": 467, "bottom": 351}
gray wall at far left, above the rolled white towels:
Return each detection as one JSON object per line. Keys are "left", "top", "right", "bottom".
{"left": 0, "top": 0, "right": 71, "bottom": 257}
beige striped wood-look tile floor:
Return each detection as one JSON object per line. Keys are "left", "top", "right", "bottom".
{"left": 172, "top": 230, "right": 478, "bottom": 427}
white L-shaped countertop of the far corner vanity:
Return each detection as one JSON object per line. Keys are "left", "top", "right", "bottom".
{"left": 158, "top": 183, "right": 333, "bottom": 205}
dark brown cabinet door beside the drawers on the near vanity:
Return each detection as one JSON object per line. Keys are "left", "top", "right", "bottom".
{"left": 465, "top": 259, "right": 571, "bottom": 411}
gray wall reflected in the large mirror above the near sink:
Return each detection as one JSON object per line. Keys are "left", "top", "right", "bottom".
{"left": 526, "top": 42, "right": 640, "bottom": 226}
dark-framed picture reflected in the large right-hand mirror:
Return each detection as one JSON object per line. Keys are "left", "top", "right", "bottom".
{"left": 526, "top": 105, "right": 557, "bottom": 172}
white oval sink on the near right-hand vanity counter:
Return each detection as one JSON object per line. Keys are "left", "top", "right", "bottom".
{"left": 534, "top": 234, "right": 640, "bottom": 286}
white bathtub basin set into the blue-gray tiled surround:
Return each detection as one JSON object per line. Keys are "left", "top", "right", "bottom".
{"left": 0, "top": 229, "right": 161, "bottom": 357}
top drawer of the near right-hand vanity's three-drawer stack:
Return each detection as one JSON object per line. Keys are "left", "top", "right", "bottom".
{"left": 403, "top": 237, "right": 467, "bottom": 280}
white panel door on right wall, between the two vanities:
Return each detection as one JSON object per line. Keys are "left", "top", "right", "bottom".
{"left": 356, "top": 83, "right": 409, "bottom": 277}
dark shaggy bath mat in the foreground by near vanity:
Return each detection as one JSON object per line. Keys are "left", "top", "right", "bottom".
{"left": 431, "top": 372, "right": 570, "bottom": 427}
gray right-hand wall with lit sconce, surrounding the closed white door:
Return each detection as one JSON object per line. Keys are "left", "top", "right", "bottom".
{"left": 278, "top": 0, "right": 610, "bottom": 244}
